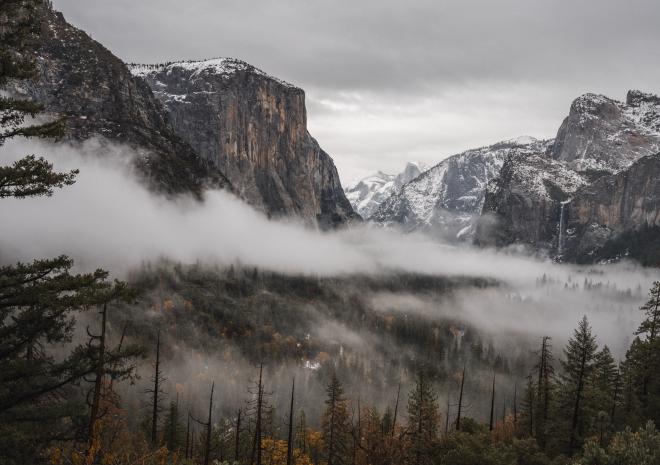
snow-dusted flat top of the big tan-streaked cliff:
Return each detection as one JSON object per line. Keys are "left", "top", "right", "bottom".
{"left": 128, "top": 58, "right": 296, "bottom": 88}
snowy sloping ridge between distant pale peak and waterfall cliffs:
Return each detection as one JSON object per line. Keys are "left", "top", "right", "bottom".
{"left": 369, "top": 136, "right": 551, "bottom": 240}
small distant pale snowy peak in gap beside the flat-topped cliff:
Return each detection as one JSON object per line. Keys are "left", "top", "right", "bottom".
{"left": 346, "top": 162, "right": 426, "bottom": 219}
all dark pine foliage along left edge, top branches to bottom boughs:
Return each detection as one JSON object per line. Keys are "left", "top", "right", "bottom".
{"left": 0, "top": 5, "right": 144, "bottom": 463}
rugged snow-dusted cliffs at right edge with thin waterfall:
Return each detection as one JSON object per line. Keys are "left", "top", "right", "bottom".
{"left": 476, "top": 90, "right": 660, "bottom": 260}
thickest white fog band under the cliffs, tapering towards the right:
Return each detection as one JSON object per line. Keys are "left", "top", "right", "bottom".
{"left": 0, "top": 141, "right": 656, "bottom": 285}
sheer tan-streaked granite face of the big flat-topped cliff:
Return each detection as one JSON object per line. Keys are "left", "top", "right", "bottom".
{"left": 132, "top": 58, "right": 359, "bottom": 228}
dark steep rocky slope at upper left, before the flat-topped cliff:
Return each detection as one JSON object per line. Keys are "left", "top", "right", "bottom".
{"left": 8, "top": 1, "right": 229, "bottom": 195}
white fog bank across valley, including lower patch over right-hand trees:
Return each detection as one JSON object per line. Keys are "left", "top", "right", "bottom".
{"left": 0, "top": 141, "right": 658, "bottom": 353}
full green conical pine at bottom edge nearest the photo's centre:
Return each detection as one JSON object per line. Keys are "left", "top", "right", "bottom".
{"left": 321, "top": 372, "right": 350, "bottom": 465}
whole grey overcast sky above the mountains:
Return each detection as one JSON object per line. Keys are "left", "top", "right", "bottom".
{"left": 53, "top": 0, "right": 660, "bottom": 184}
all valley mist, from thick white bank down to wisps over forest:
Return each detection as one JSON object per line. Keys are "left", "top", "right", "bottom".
{"left": 0, "top": 140, "right": 659, "bottom": 423}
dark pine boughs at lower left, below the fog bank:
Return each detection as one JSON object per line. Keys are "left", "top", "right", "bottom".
{"left": 0, "top": 257, "right": 142, "bottom": 463}
